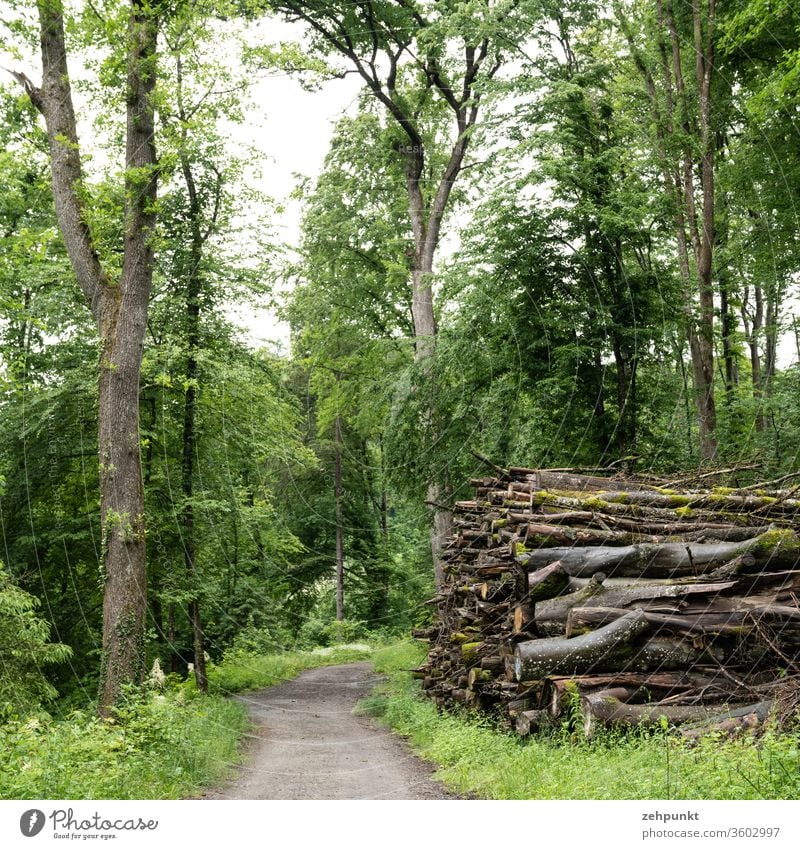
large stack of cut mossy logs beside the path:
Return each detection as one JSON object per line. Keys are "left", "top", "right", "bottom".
{"left": 415, "top": 468, "right": 800, "bottom": 737}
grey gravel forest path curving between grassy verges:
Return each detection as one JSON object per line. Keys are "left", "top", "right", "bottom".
{"left": 204, "top": 663, "right": 449, "bottom": 799}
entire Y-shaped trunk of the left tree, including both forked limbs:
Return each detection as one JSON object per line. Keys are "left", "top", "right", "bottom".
{"left": 22, "top": 0, "right": 157, "bottom": 714}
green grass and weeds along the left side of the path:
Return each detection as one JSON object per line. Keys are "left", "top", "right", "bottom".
{"left": 0, "top": 646, "right": 371, "bottom": 799}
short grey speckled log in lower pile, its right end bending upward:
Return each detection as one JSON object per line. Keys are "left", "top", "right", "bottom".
{"left": 514, "top": 610, "right": 649, "bottom": 681}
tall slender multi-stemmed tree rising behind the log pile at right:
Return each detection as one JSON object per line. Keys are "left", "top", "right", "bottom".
{"left": 616, "top": 0, "right": 717, "bottom": 460}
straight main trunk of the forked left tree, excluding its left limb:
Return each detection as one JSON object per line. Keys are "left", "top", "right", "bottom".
{"left": 96, "top": 0, "right": 157, "bottom": 713}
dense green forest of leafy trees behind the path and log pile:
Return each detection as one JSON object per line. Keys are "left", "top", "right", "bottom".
{"left": 0, "top": 0, "right": 800, "bottom": 714}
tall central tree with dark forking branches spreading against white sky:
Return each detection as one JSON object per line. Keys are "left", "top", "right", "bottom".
{"left": 257, "top": 0, "right": 525, "bottom": 581}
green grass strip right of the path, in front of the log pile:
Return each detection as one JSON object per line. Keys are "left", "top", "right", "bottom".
{"left": 362, "top": 642, "right": 800, "bottom": 799}
